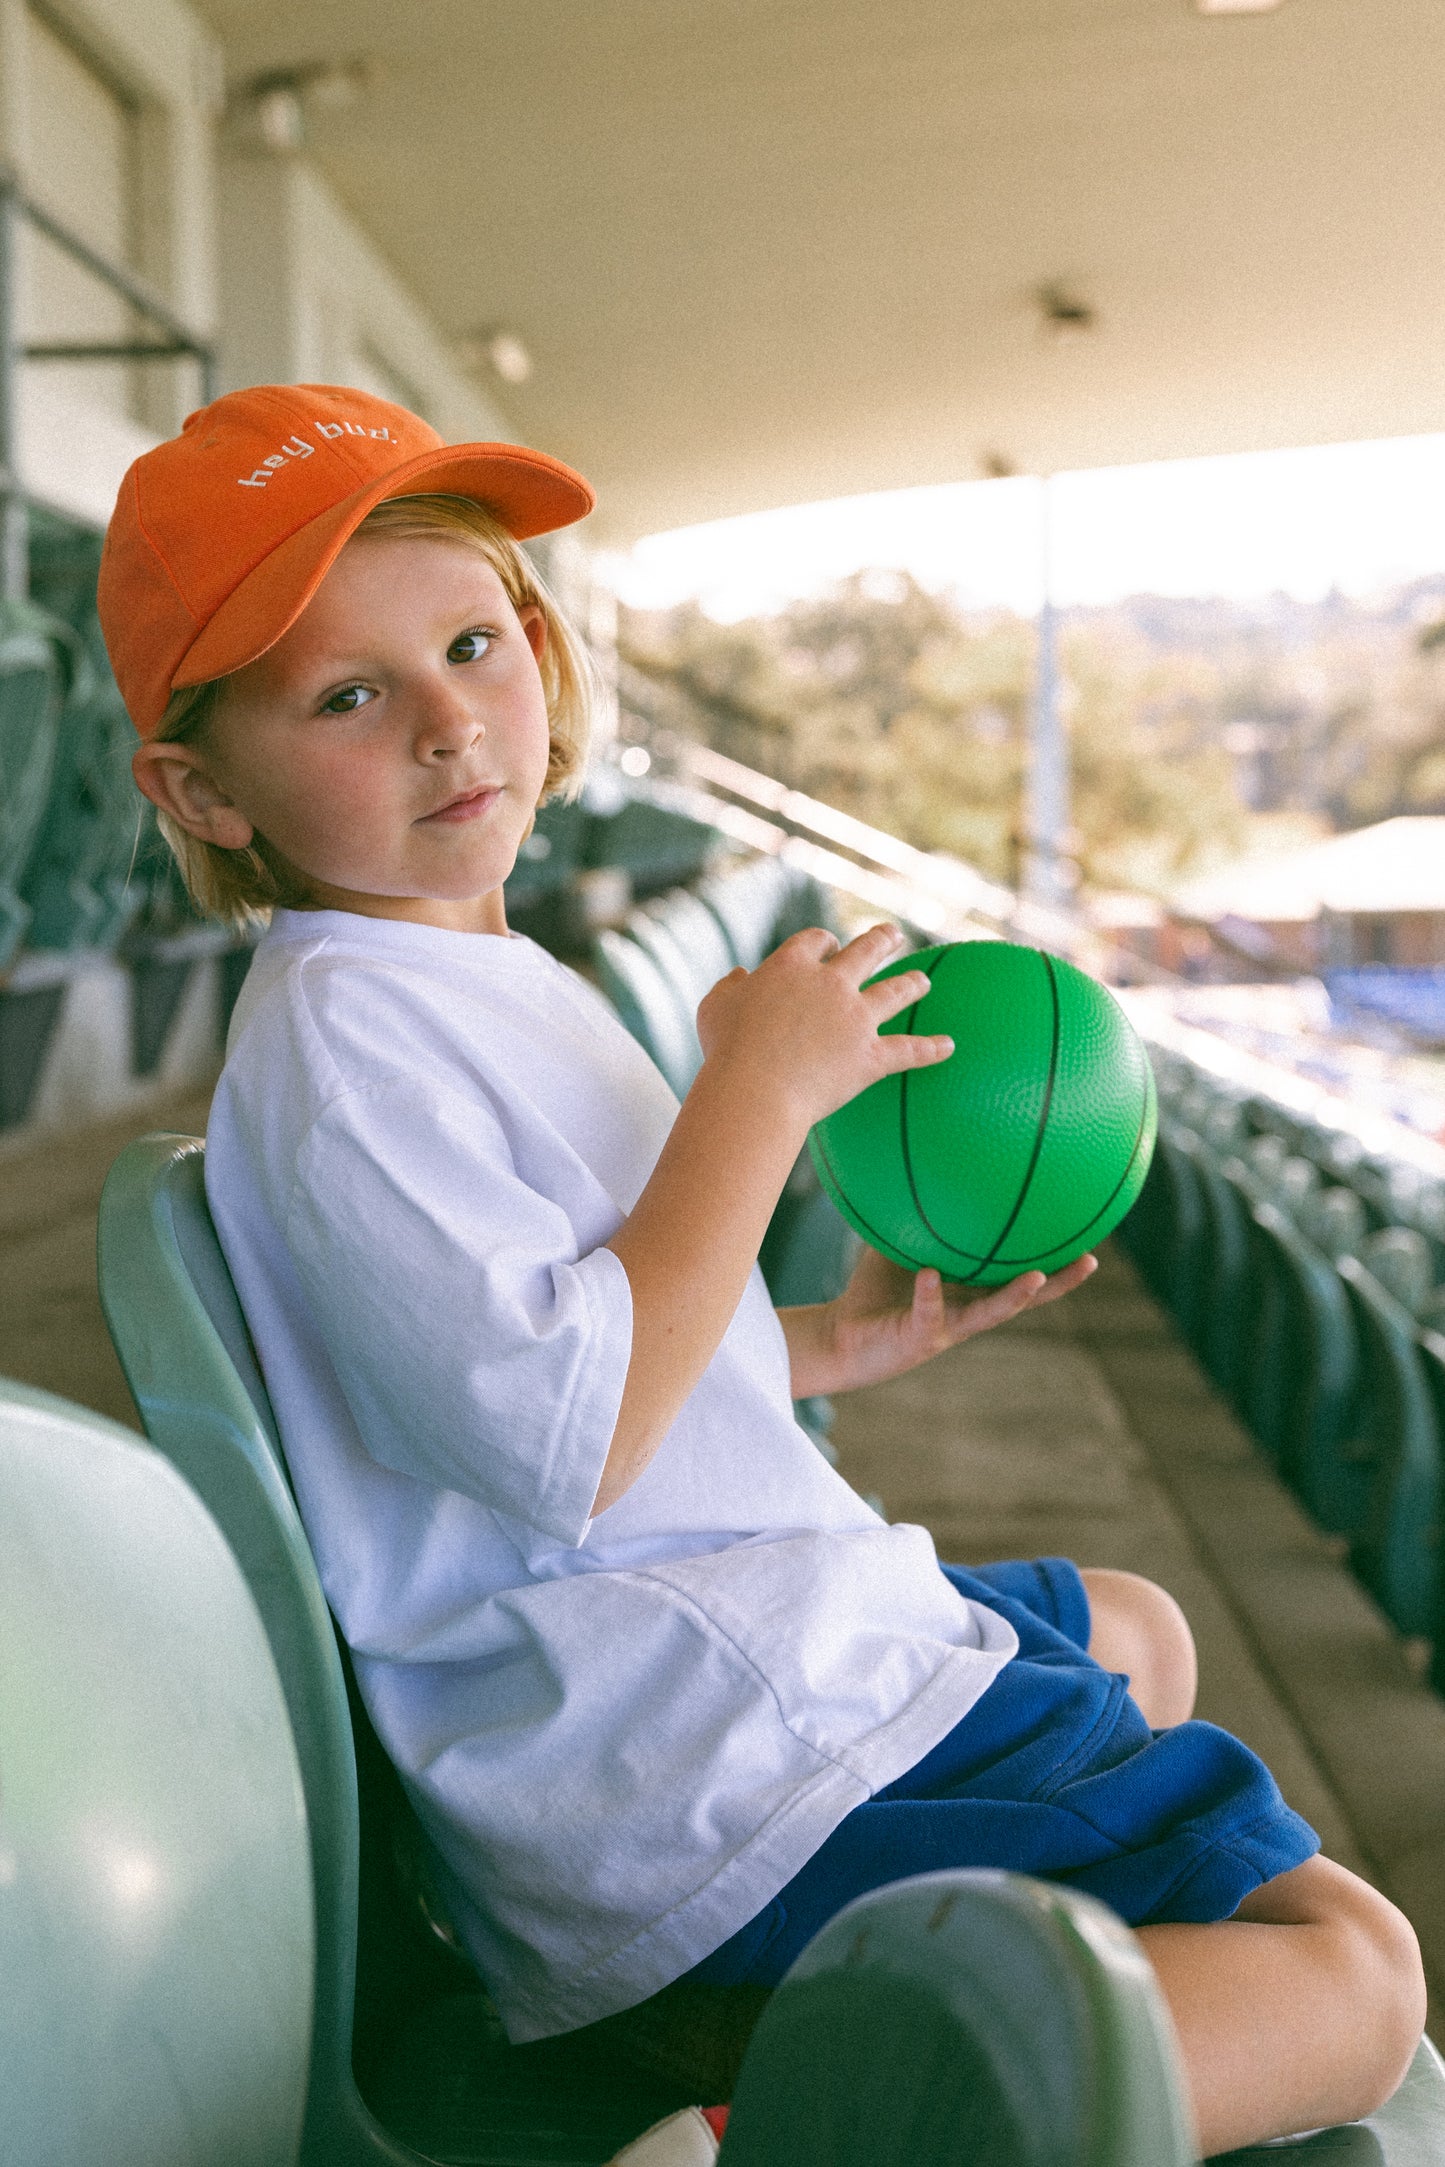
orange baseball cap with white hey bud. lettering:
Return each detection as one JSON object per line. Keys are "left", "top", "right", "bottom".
{"left": 97, "top": 384, "right": 596, "bottom": 737}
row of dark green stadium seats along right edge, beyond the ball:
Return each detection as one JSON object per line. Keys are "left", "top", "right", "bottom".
{"left": 1120, "top": 1055, "right": 1445, "bottom": 1664}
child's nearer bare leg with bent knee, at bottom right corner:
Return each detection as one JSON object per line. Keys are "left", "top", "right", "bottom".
{"left": 1137, "top": 1857, "right": 1426, "bottom": 2156}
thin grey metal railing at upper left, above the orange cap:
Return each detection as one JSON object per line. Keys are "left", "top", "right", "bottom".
{"left": 0, "top": 171, "right": 217, "bottom": 596}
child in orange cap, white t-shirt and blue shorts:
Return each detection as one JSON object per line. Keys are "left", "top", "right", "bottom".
{"left": 100, "top": 386, "right": 1423, "bottom": 2152}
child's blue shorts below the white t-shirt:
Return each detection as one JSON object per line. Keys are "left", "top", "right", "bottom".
{"left": 689, "top": 1558, "right": 1319, "bottom": 1985}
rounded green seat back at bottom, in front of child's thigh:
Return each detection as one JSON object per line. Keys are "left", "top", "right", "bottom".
{"left": 719, "top": 1870, "right": 1194, "bottom": 2167}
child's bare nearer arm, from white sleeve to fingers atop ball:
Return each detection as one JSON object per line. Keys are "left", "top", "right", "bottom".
{"left": 594, "top": 925, "right": 953, "bottom": 1513}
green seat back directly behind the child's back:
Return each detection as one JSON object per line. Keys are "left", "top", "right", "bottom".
{"left": 97, "top": 1136, "right": 409, "bottom": 2163}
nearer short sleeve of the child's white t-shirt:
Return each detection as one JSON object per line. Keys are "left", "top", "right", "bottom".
{"left": 286, "top": 1081, "right": 633, "bottom": 1545}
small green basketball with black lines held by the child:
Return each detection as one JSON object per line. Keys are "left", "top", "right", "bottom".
{"left": 808, "top": 940, "right": 1157, "bottom": 1287}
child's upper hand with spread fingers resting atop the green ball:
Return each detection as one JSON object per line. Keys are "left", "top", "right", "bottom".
{"left": 698, "top": 925, "right": 953, "bottom": 1129}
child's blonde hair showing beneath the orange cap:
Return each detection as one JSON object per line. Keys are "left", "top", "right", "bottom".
{"left": 154, "top": 494, "right": 594, "bottom": 925}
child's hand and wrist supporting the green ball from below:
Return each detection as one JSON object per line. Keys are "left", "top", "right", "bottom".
{"left": 780, "top": 1248, "right": 1098, "bottom": 1400}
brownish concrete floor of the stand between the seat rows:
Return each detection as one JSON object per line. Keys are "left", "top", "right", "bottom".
{"left": 0, "top": 1092, "right": 1445, "bottom": 2039}
